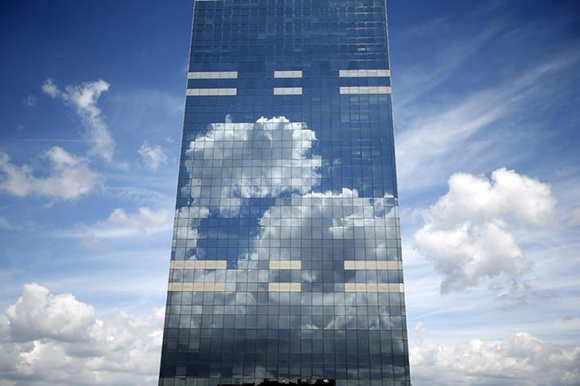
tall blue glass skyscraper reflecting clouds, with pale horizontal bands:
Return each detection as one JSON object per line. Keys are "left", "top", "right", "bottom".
{"left": 160, "top": 0, "right": 410, "bottom": 386}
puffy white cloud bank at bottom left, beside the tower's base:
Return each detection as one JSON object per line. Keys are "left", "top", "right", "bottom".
{"left": 0, "top": 284, "right": 163, "bottom": 385}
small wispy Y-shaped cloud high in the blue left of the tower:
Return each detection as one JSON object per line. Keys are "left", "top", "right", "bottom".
{"left": 42, "top": 79, "right": 115, "bottom": 163}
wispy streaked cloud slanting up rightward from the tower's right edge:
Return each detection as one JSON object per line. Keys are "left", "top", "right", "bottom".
{"left": 397, "top": 53, "right": 580, "bottom": 190}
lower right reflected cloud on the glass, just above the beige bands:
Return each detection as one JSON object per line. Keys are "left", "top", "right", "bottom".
{"left": 250, "top": 188, "right": 398, "bottom": 266}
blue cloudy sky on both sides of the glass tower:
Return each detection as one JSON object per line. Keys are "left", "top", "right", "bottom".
{"left": 0, "top": 0, "right": 580, "bottom": 385}
